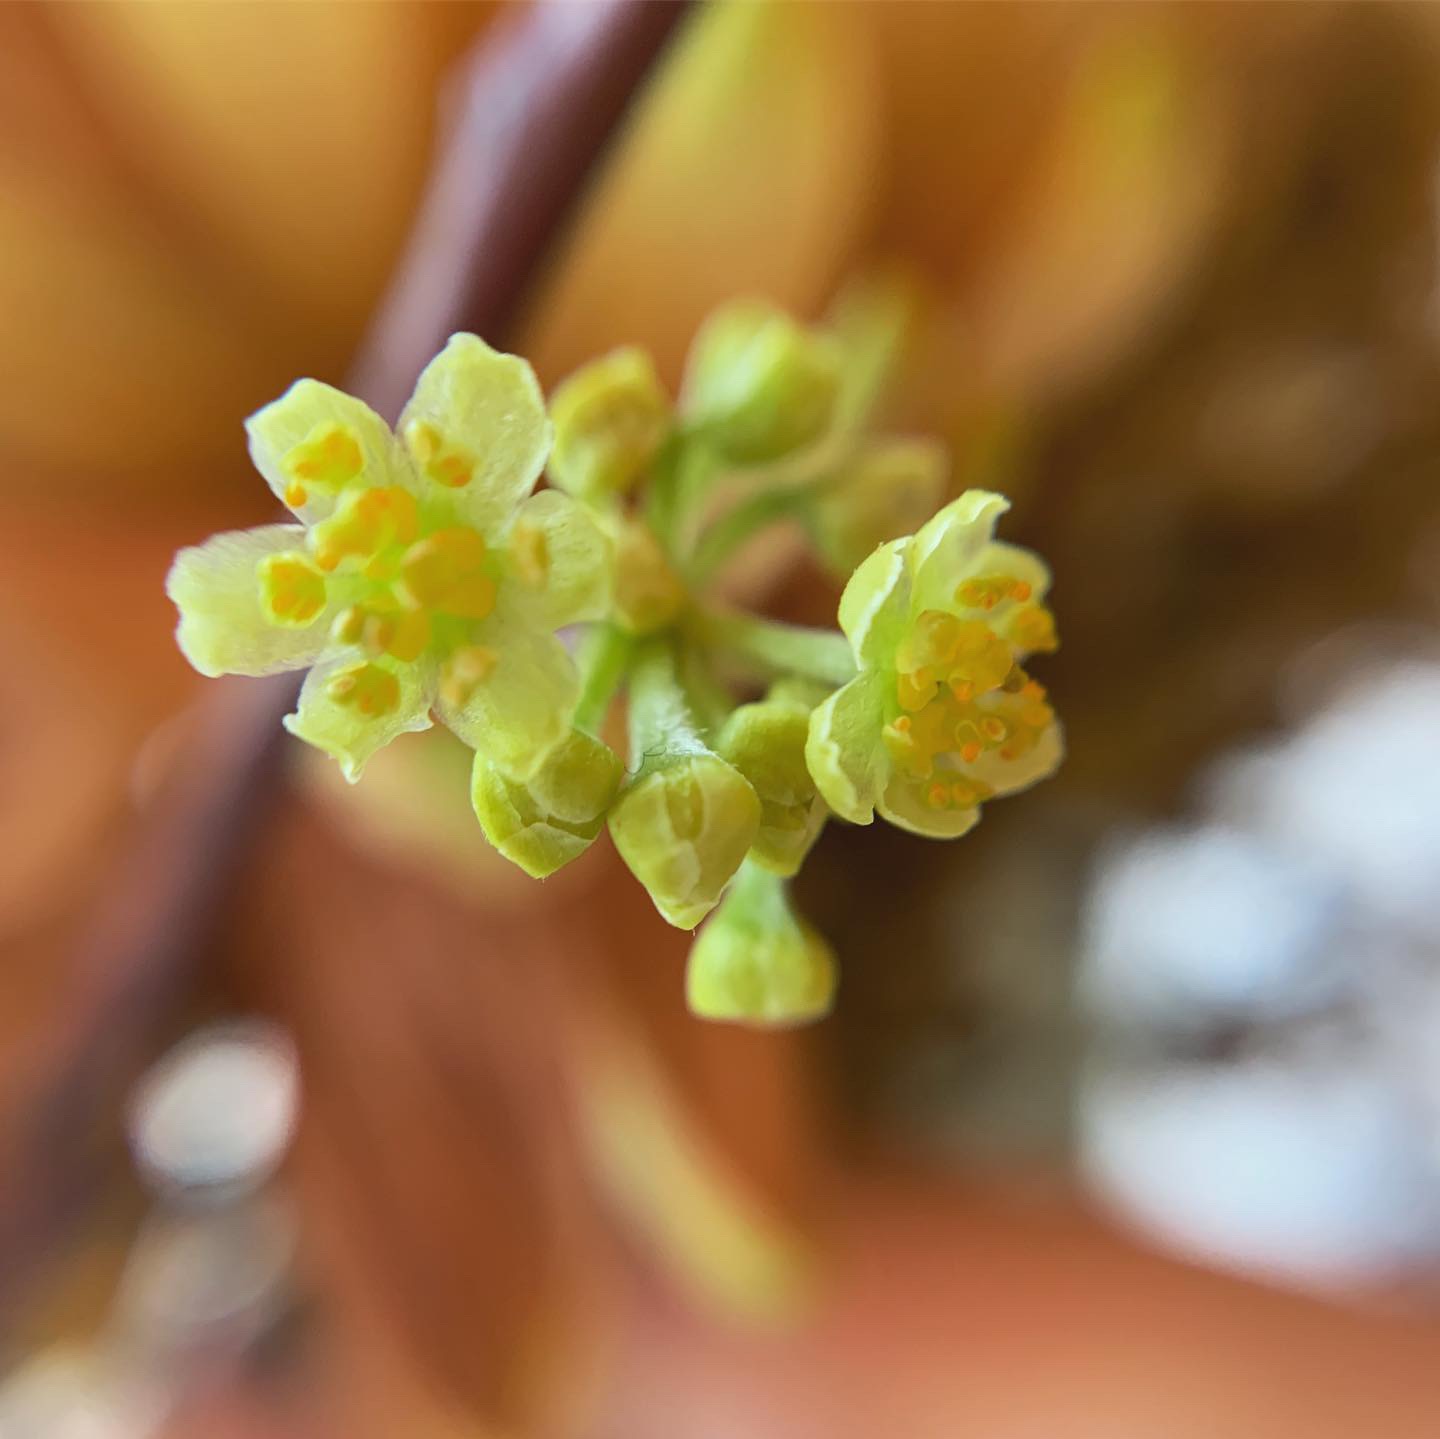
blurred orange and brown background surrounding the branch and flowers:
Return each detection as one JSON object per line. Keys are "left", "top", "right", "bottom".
{"left": 8, "top": 0, "right": 1440, "bottom": 1439}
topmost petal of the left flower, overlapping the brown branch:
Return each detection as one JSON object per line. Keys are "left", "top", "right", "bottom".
{"left": 397, "top": 334, "right": 550, "bottom": 537}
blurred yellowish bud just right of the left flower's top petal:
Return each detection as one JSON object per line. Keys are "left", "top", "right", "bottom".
{"left": 550, "top": 347, "right": 670, "bottom": 500}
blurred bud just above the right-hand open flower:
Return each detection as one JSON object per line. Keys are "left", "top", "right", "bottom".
{"left": 808, "top": 439, "right": 945, "bottom": 579}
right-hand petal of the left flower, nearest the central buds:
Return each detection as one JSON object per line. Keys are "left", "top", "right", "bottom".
{"left": 508, "top": 490, "right": 615, "bottom": 629}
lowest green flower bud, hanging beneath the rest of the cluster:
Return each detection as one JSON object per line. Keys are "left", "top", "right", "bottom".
{"left": 685, "top": 864, "right": 835, "bottom": 1024}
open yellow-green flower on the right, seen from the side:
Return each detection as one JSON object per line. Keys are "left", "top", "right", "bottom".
{"left": 805, "top": 490, "right": 1061, "bottom": 838}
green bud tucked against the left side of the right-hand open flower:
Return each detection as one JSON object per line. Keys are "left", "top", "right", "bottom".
{"left": 716, "top": 691, "right": 828, "bottom": 874}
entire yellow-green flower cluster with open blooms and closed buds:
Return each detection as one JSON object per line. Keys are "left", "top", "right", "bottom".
{"left": 167, "top": 301, "right": 1061, "bottom": 1024}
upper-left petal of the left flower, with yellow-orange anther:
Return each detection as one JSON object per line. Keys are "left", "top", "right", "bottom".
{"left": 245, "top": 380, "right": 397, "bottom": 524}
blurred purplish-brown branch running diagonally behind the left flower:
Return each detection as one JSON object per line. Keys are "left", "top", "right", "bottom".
{"left": 0, "top": 0, "right": 685, "bottom": 1312}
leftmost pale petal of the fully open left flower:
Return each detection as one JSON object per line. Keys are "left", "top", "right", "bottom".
{"left": 166, "top": 524, "right": 336, "bottom": 677}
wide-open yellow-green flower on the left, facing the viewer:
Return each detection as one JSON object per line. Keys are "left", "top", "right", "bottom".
{"left": 167, "top": 334, "right": 611, "bottom": 781}
